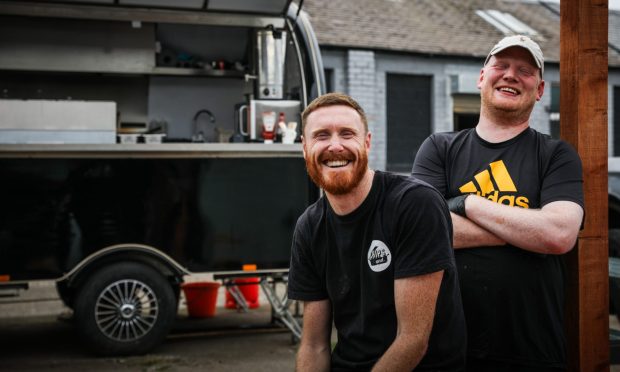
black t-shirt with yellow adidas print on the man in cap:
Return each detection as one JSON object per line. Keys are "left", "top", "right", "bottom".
{"left": 413, "top": 128, "right": 583, "bottom": 368}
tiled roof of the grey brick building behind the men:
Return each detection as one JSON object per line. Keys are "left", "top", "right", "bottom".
{"left": 303, "top": 0, "right": 620, "bottom": 66}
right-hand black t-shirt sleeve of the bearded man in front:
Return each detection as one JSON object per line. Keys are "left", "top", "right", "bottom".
{"left": 394, "top": 186, "right": 454, "bottom": 279}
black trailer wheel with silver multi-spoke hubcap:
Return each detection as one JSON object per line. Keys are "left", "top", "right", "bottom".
{"left": 74, "top": 262, "right": 177, "bottom": 356}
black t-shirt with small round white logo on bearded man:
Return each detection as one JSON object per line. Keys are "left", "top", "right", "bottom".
{"left": 288, "top": 171, "right": 466, "bottom": 371}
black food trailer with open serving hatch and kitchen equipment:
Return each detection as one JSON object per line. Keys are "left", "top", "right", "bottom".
{"left": 0, "top": 0, "right": 325, "bottom": 355}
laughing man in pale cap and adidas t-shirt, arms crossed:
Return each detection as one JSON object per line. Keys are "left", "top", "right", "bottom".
{"left": 412, "top": 35, "right": 584, "bottom": 372}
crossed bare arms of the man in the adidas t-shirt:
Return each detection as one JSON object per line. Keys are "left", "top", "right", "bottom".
{"left": 452, "top": 195, "right": 583, "bottom": 254}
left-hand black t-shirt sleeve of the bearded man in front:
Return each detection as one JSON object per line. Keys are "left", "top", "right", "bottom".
{"left": 288, "top": 214, "right": 327, "bottom": 301}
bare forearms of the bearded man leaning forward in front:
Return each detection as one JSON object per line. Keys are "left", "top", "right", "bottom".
{"left": 297, "top": 270, "right": 443, "bottom": 372}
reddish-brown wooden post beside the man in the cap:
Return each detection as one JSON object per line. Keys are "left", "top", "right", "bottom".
{"left": 560, "top": 0, "right": 609, "bottom": 372}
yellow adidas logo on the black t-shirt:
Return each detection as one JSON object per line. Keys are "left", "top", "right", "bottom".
{"left": 459, "top": 160, "right": 530, "bottom": 208}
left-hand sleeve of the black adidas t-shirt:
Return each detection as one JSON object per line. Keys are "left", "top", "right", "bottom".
{"left": 411, "top": 135, "right": 447, "bottom": 195}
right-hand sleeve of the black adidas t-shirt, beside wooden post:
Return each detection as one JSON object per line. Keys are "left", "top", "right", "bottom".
{"left": 540, "top": 141, "right": 584, "bottom": 208}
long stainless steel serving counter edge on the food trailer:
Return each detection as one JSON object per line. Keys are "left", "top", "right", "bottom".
{"left": 0, "top": 143, "right": 302, "bottom": 158}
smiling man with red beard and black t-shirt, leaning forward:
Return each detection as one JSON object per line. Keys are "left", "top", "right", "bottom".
{"left": 288, "top": 93, "right": 466, "bottom": 372}
